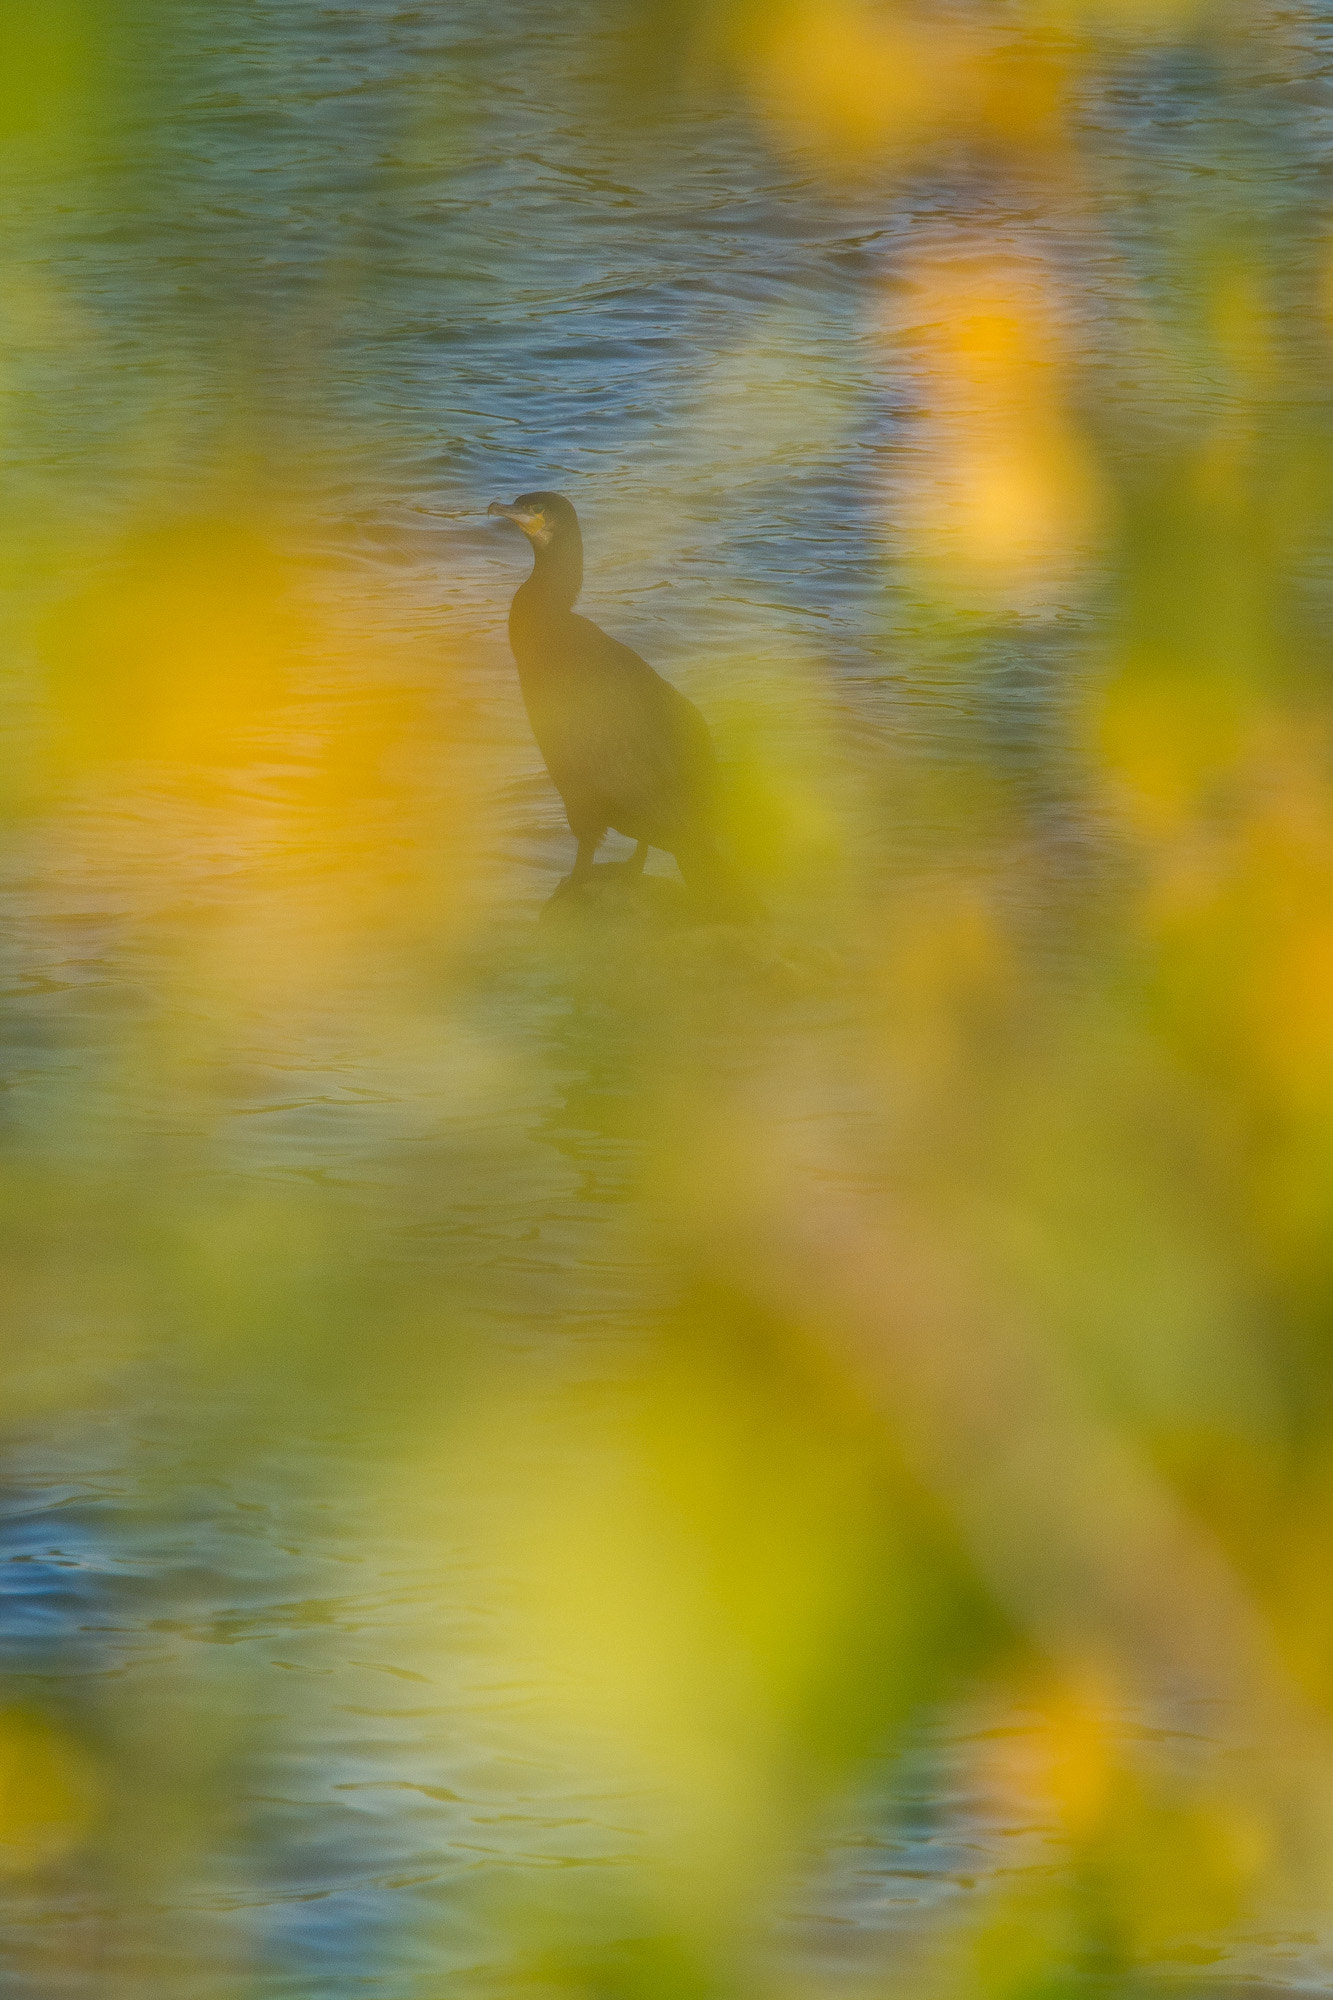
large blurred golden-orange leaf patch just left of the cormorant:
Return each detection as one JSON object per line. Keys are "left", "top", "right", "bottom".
{"left": 40, "top": 480, "right": 488, "bottom": 1020}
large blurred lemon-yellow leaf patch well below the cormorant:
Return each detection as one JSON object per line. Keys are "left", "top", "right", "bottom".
{"left": 400, "top": 1326, "right": 908, "bottom": 1888}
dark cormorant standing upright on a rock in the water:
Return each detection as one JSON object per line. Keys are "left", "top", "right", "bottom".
{"left": 488, "top": 492, "right": 759, "bottom": 920}
